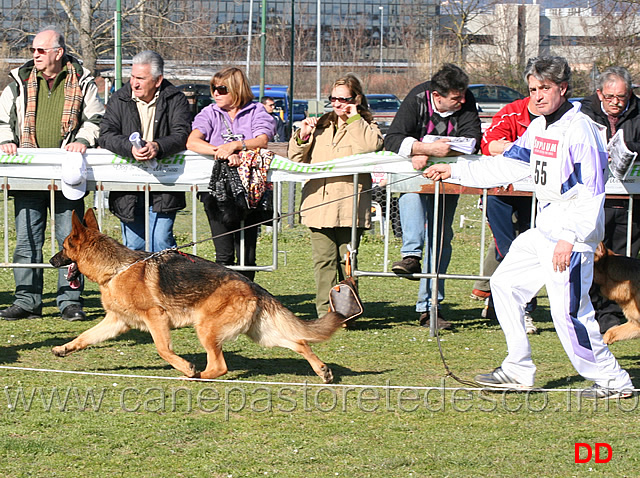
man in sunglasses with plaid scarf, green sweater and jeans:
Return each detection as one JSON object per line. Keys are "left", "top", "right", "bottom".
{"left": 0, "top": 27, "right": 104, "bottom": 320}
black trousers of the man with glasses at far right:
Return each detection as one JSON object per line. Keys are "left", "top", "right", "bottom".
{"left": 589, "top": 199, "right": 640, "bottom": 334}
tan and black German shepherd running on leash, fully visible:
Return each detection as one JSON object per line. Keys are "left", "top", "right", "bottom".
{"left": 50, "top": 209, "right": 345, "bottom": 383}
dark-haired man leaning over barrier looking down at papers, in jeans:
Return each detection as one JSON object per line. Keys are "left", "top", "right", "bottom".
{"left": 384, "top": 64, "right": 482, "bottom": 329}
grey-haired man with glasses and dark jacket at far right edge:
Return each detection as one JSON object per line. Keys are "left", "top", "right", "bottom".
{"left": 582, "top": 66, "right": 640, "bottom": 334}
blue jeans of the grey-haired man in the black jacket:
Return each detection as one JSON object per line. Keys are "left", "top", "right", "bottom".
{"left": 120, "top": 201, "right": 176, "bottom": 252}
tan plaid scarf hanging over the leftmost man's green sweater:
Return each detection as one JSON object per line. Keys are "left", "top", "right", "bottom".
{"left": 20, "top": 61, "right": 82, "bottom": 148}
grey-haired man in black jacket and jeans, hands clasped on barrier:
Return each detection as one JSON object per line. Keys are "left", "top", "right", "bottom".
{"left": 98, "top": 50, "right": 191, "bottom": 252}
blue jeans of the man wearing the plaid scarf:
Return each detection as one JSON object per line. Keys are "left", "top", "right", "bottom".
{"left": 13, "top": 191, "right": 84, "bottom": 314}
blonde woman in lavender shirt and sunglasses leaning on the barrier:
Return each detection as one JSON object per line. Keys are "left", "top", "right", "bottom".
{"left": 187, "top": 68, "right": 276, "bottom": 280}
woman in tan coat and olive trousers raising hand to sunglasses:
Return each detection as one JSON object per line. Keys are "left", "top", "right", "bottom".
{"left": 289, "top": 75, "right": 383, "bottom": 317}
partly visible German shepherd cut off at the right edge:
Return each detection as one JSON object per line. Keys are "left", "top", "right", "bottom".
{"left": 593, "top": 242, "right": 640, "bottom": 344}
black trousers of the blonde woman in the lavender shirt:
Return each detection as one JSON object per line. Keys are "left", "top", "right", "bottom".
{"left": 203, "top": 196, "right": 263, "bottom": 280}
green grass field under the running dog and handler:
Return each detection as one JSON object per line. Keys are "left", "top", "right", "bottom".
{"left": 0, "top": 192, "right": 640, "bottom": 477}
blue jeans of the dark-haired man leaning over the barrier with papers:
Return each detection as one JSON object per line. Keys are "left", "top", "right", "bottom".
{"left": 398, "top": 193, "right": 458, "bottom": 313}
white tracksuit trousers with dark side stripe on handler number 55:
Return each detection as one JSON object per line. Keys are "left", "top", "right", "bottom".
{"left": 491, "top": 228, "right": 633, "bottom": 390}
